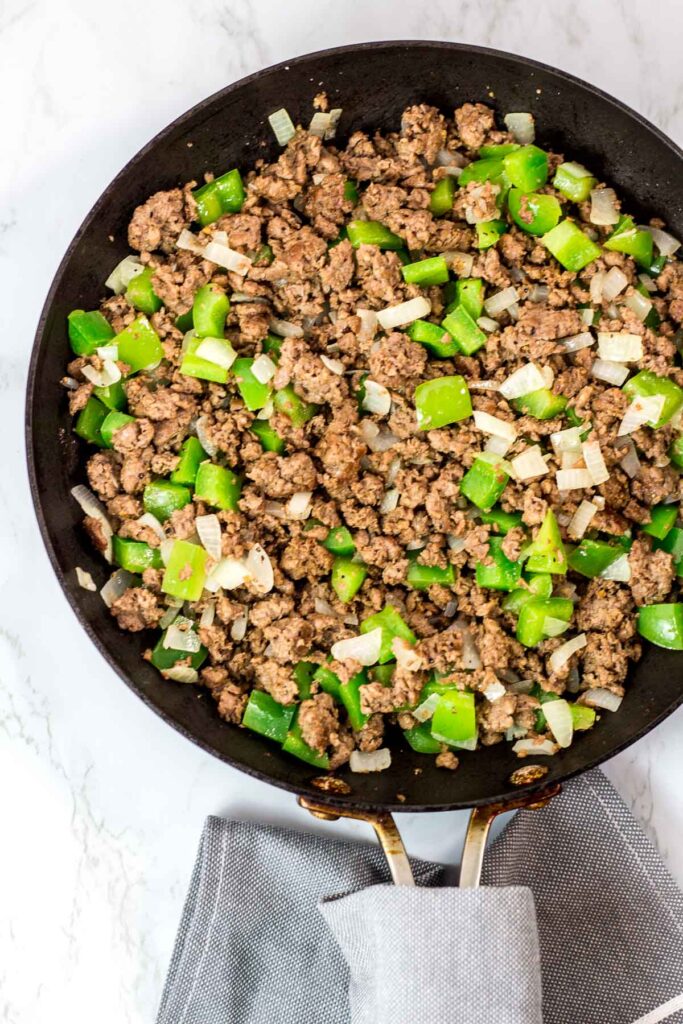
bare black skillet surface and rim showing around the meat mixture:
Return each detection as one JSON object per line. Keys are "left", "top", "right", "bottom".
{"left": 27, "top": 42, "right": 683, "bottom": 811}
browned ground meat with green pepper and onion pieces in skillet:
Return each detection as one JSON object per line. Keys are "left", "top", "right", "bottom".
{"left": 63, "top": 95, "right": 683, "bottom": 771}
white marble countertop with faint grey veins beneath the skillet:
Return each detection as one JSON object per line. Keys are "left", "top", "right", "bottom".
{"left": 0, "top": 0, "right": 683, "bottom": 1024}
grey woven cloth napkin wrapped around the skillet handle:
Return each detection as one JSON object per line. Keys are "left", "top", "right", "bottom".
{"left": 158, "top": 771, "right": 683, "bottom": 1024}
